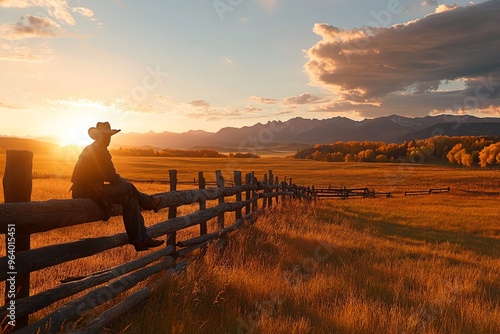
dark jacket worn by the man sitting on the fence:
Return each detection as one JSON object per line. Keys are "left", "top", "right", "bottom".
{"left": 71, "top": 142, "right": 122, "bottom": 187}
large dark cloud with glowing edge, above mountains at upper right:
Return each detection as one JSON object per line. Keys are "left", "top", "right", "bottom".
{"left": 305, "top": 1, "right": 500, "bottom": 116}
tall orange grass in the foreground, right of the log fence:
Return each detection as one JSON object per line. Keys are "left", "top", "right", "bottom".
{"left": 110, "top": 200, "right": 500, "bottom": 333}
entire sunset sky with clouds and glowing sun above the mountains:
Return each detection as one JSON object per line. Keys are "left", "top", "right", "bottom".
{"left": 0, "top": 0, "right": 500, "bottom": 143}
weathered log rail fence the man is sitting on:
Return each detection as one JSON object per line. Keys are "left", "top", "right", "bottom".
{"left": 0, "top": 153, "right": 314, "bottom": 333}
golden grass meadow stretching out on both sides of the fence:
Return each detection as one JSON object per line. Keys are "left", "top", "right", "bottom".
{"left": 0, "top": 154, "right": 500, "bottom": 333}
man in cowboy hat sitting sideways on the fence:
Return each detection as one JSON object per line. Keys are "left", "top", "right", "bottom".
{"left": 71, "top": 122, "right": 164, "bottom": 252}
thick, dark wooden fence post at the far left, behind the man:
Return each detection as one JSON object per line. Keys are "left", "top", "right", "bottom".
{"left": 2, "top": 150, "right": 33, "bottom": 329}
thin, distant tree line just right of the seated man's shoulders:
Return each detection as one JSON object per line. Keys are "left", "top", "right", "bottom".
{"left": 110, "top": 147, "right": 260, "bottom": 158}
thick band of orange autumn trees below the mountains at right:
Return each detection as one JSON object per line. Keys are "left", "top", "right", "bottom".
{"left": 293, "top": 136, "right": 500, "bottom": 167}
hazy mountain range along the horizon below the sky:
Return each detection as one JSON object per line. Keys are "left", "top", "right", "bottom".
{"left": 113, "top": 115, "right": 500, "bottom": 152}
